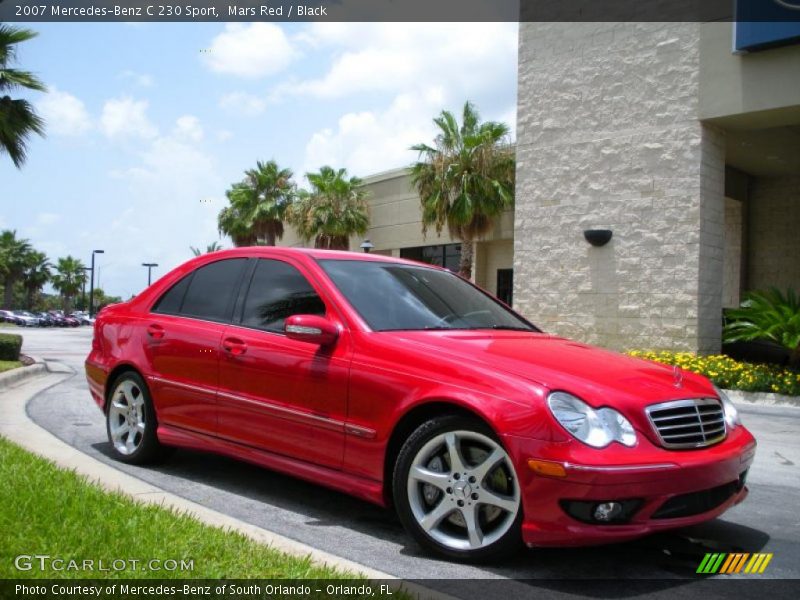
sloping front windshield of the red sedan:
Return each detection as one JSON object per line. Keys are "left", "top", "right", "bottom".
{"left": 319, "top": 260, "right": 539, "bottom": 331}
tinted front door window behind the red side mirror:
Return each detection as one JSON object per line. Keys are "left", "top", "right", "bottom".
{"left": 242, "top": 259, "right": 325, "bottom": 332}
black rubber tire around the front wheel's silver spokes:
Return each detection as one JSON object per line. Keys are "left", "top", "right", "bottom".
{"left": 392, "top": 415, "right": 523, "bottom": 562}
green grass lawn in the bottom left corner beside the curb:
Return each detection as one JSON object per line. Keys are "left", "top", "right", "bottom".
{"left": 0, "top": 437, "right": 360, "bottom": 579}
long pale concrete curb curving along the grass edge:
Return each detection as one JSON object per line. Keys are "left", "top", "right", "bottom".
{"left": 0, "top": 370, "right": 404, "bottom": 584}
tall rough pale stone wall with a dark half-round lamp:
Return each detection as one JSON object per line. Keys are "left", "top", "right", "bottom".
{"left": 514, "top": 23, "right": 725, "bottom": 351}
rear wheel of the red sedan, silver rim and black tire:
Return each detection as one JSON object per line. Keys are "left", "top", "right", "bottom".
{"left": 106, "top": 371, "right": 172, "bottom": 465}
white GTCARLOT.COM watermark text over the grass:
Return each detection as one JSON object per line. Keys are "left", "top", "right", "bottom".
{"left": 14, "top": 554, "right": 194, "bottom": 573}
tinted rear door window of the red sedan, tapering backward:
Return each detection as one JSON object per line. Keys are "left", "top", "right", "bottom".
{"left": 153, "top": 258, "right": 247, "bottom": 321}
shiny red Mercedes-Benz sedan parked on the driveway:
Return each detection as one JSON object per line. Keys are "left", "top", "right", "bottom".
{"left": 86, "top": 247, "right": 756, "bottom": 560}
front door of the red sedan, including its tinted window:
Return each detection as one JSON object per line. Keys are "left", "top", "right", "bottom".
{"left": 218, "top": 259, "right": 350, "bottom": 468}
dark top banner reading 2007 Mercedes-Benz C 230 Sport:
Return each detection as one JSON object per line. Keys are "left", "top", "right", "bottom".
{"left": 0, "top": 0, "right": 800, "bottom": 22}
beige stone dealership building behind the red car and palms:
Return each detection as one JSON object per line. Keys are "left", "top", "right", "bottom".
{"left": 283, "top": 23, "right": 800, "bottom": 352}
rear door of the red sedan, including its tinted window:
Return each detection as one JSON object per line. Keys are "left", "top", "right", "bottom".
{"left": 145, "top": 258, "right": 247, "bottom": 434}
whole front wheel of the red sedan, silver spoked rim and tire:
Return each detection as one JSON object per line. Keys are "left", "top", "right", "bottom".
{"left": 393, "top": 416, "right": 522, "bottom": 561}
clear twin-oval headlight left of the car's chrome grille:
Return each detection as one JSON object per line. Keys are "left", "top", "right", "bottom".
{"left": 547, "top": 392, "right": 636, "bottom": 448}
